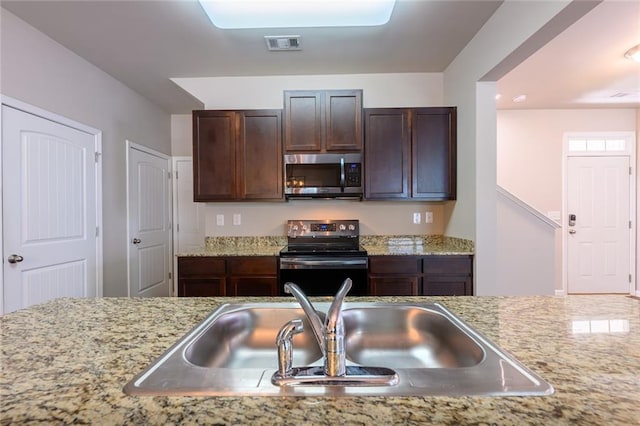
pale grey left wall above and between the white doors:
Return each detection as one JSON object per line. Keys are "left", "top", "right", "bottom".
{"left": 0, "top": 9, "right": 171, "bottom": 296}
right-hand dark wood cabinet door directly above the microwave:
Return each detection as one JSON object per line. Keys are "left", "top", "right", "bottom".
{"left": 324, "top": 90, "right": 363, "bottom": 152}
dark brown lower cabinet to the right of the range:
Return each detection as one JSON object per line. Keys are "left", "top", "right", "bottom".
{"left": 369, "top": 255, "right": 473, "bottom": 296}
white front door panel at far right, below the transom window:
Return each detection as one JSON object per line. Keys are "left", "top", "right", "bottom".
{"left": 567, "top": 156, "right": 630, "bottom": 293}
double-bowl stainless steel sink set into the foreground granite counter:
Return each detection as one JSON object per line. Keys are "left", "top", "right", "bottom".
{"left": 124, "top": 303, "right": 553, "bottom": 396}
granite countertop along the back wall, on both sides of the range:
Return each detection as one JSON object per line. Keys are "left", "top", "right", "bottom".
{"left": 177, "top": 235, "right": 474, "bottom": 257}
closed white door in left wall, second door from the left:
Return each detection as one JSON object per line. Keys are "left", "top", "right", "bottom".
{"left": 127, "top": 143, "right": 172, "bottom": 297}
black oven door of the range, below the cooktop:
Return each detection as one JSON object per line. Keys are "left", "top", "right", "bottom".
{"left": 280, "top": 256, "right": 368, "bottom": 296}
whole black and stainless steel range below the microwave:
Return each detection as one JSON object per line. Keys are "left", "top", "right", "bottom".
{"left": 280, "top": 220, "right": 368, "bottom": 296}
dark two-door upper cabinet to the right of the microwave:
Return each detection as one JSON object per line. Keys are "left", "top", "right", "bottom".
{"left": 364, "top": 107, "right": 456, "bottom": 201}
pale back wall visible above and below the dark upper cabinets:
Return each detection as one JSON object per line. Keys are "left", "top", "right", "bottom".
{"left": 171, "top": 73, "right": 444, "bottom": 240}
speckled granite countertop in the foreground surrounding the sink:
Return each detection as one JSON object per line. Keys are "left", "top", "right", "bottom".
{"left": 0, "top": 295, "right": 640, "bottom": 425}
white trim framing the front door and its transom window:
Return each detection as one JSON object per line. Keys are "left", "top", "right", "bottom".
{"left": 561, "top": 132, "right": 640, "bottom": 295}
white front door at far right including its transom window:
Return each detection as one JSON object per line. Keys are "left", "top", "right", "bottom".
{"left": 563, "top": 132, "right": 635, "bottom": 294}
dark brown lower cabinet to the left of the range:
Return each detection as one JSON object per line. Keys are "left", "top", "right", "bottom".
{"left": 178, "top": 256, "right": 278, "bottom": 297}
